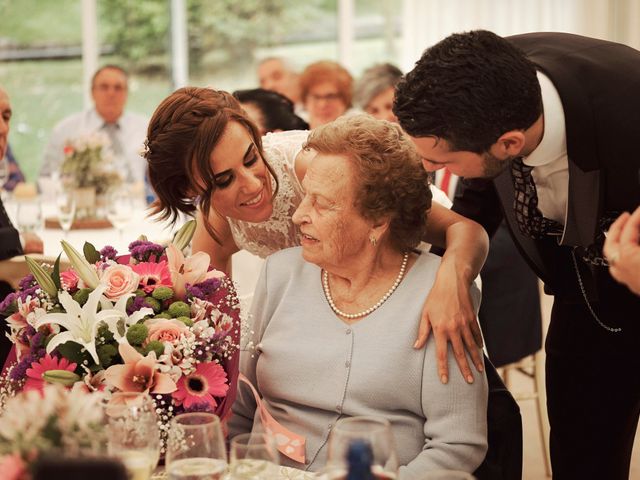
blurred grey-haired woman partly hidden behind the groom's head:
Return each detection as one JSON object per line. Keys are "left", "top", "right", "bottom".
{"left": 353, "top": 63, "right": 402, "bottom": 123}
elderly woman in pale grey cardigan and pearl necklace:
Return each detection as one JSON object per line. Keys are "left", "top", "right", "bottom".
{"left": 230, "top": 115, "right": 487, "bottom": 479}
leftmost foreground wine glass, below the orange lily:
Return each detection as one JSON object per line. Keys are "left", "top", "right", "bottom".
{"left": 105, "top": 392, "right": 160, "bottom": 480}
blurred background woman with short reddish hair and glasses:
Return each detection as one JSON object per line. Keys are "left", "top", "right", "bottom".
{"left": 299, "top": 60, "right": 353, "bottom": 128}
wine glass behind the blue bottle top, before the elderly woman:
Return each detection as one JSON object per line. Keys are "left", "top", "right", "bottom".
{"left": 324, "top": 417, "right": 398, "bottom": 479}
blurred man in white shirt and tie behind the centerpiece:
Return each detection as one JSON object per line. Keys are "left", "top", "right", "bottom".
{"left": 40, "top": 65, "right": 148, "bottom": 183}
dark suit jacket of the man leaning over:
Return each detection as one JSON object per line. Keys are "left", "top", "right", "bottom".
{"left": 453, "top": 33, "right": 640, "bottom": 300}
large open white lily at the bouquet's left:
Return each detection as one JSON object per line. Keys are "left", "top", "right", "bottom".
{"left": 36, "top": 285, "right": 126, "bottom": 363}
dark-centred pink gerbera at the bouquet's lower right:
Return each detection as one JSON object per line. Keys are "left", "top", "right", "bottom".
{"left": 172, "top": 362, "right": 229, "bottom": 409}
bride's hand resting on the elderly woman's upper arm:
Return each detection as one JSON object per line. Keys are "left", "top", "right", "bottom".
{"left": 414, "top": 256, "right": 484, "bottom": 383}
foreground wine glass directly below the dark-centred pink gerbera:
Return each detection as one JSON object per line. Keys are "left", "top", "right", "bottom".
{"left": 165, "top": 412, "right": 227, "bottom": 480}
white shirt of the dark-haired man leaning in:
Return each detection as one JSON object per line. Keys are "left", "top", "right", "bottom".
{"left": 524, "top": 72, "right": 569, "bottom": 238}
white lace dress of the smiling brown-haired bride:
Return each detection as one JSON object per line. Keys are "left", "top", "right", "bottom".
{"left": 227, "top": 130, "right": 309, "bottom": 258}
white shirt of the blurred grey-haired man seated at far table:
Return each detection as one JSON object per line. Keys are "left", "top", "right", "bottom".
{"left": 40, "top": 108, "right": 149, "bottom": 183}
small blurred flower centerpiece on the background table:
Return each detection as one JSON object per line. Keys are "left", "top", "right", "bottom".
{"left": 60, "top": 132, "right": 122, "bottom": 218}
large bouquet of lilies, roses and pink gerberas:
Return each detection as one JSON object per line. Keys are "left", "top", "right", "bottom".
{"left": 0, "top": 220, "right": 240, "bottom": 456}
